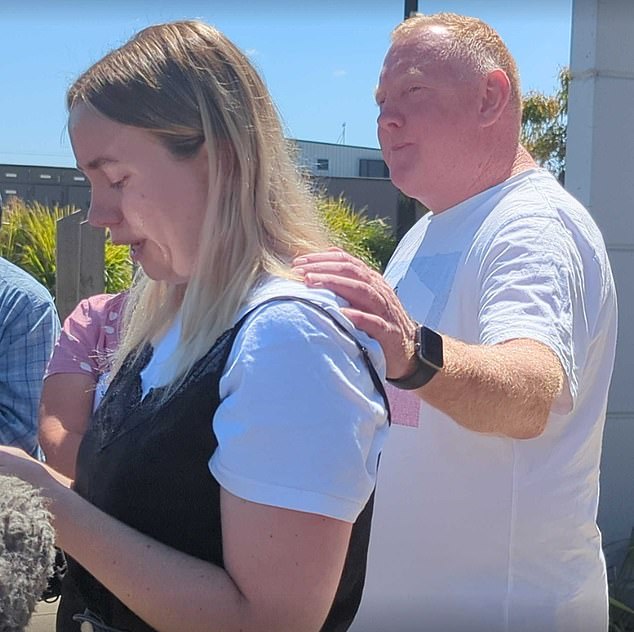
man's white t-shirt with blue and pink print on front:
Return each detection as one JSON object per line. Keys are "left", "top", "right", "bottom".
{"left": 352, "top": 169, "right": 616, "bottom": 632}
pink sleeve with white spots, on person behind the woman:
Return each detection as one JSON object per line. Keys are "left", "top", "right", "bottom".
{"left": 45, "top": 292, "right": 127, "bottom": 382}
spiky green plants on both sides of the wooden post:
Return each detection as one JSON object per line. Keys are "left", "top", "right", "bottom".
{"left": 0, "top": 198, "right": 132, "bottom": 296}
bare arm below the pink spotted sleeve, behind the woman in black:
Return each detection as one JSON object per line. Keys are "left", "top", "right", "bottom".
{"left": 39, "top": 373, "right": 95, "bottom": 478}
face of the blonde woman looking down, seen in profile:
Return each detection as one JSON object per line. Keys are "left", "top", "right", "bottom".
{"left": 69, "top": 104, "right": 208, "bottom": 284}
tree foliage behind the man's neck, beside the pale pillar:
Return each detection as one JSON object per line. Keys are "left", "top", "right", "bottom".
{"left": 521, "top": 68, "right": 570, "bottom": 182}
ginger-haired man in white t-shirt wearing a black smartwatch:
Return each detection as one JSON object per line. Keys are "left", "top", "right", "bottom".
{"left": 295, "top": 14, "right": 617, "bottom": 632}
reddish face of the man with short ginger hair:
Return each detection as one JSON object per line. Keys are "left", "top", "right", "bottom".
{"left": 376, "top": 32, "right": 479, "bottom": 212}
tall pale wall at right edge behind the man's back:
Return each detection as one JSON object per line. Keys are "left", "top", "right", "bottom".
{"left": 566, "top": 0, "right": 634, "bottom": 543}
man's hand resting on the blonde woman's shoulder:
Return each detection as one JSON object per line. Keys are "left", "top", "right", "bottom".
{"left": 293, "top": 248, "right": 416, "bottom": 378}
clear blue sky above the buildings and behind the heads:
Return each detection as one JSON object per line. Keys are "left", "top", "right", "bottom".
{"left": 0, "top": 0, "right": 572, "bottom": 166}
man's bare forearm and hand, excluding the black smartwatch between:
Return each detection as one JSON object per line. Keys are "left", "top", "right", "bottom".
{"left": 295, "top": 249, "right": 564, "bottom": 439}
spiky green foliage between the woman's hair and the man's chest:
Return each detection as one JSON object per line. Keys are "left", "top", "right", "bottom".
{"left": 318, "top": 196, "right": 396, "bottom": 271}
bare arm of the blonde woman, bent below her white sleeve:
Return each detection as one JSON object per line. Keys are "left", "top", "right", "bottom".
{"left": 0, "top": 448, "right": 351, "bottom": 632}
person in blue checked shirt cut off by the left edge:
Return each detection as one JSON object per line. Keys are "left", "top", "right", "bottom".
{"left": 0, "top": 195, "right": 60, "bottom": 456}
